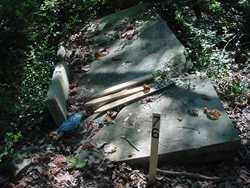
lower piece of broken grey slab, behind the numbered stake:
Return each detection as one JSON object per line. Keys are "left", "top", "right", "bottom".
{"left": 94, "top": 76, "right": 239, "bottom": 162}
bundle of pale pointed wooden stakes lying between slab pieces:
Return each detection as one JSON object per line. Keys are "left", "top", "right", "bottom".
{"left": 85, "top": 75, "right": 175, "bottom": 113}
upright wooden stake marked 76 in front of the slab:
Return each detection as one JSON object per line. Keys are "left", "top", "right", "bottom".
{"left": 149, "top": 113, "right": 161, "bottom": 180}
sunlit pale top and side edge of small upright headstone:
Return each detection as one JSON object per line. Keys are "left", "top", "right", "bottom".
{"left": 52, "top": 64, "right": 69, "bottom": 100}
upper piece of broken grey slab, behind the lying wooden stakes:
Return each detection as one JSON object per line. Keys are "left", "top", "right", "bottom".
{"left": 80, "top": 4, "right": 186, "bottom": 95}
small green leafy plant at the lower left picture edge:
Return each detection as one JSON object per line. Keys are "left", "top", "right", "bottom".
{"left": 0, "top": 132, "right": 22, "bottom": 163}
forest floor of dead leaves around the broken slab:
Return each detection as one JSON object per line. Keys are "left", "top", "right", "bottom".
{"left": 0, "top": 1, "right": 250, "bottom": 188}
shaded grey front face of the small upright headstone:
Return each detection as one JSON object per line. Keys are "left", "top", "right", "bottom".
{"left": 46, "top": 79, "right": 67, "bottom": 126}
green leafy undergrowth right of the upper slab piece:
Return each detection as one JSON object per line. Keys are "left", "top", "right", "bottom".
{"left": 159, "top": 0, "right": 250, "bottom": 98}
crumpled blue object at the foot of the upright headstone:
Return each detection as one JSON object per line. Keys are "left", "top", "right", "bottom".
{"left": 56, "top": 113, "right": 82, "bottom": 133}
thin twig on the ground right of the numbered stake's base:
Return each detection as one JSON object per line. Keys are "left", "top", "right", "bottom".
{"left": 157, "top": 169, "right": 221, "bottom": 181}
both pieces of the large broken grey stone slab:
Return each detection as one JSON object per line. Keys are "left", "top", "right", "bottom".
{"left": 74, "top": 4, "right": 239, "bottom": 162}
